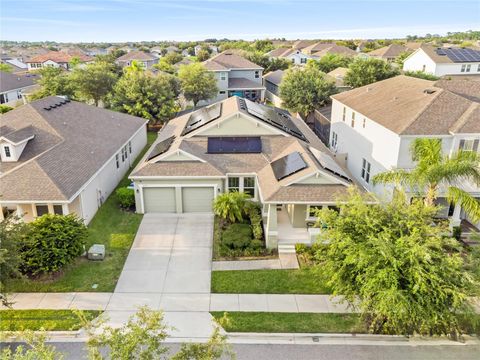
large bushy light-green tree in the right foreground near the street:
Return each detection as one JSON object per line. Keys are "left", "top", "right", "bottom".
{"left": 316, "top": 190, "right": 478, "bottom": 336}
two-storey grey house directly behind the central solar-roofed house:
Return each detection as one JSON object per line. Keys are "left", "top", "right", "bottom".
{"left": 203, "top": 50, "right": 265, "bottom": 102}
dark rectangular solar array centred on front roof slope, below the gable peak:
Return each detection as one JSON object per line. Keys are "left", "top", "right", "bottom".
{"left": 207, "top": 136, "right": 262, "bottom": 154}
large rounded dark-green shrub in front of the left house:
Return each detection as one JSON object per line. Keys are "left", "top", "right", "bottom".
{"left": 21, "top": 214, "right": 88, "bottom": 275}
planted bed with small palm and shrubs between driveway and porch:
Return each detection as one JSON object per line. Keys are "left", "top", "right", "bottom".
{"left": 213, "top": 192, "right": 274, "bottom": 260}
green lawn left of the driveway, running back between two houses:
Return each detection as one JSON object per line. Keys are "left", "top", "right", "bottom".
{"left": 7, "top": 132, "right": 156, "bottom": 292}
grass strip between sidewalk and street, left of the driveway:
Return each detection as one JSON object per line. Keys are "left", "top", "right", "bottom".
{"left": 0, "top": 310, "right": 101, "bottom": 331}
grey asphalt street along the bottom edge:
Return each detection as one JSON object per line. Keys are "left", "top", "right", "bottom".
{"left": 2, "top": 342, "right": 480, "bottom": 360}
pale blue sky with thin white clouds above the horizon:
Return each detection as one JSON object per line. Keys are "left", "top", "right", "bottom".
{"left": 0, "top": 0, "right": 480, "bottom": 42}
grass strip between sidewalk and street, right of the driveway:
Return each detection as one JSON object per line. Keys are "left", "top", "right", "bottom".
{"left": 212, "top": 312, "right": 367, "bottom": 333}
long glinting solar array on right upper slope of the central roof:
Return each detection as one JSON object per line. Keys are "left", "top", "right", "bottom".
{"left": 239, "top": 99, "right": 308, "bottom": 142}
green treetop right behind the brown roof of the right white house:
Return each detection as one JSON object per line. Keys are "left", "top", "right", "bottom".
{"left": 343, "top": 58, "right": 400, "bottom": 88}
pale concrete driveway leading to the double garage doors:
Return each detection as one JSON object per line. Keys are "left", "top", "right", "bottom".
{"left": 106, "top": 214, "right": 218, "bottom": 338}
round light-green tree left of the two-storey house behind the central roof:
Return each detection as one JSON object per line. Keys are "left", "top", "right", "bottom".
{"left": 178, "top": 63, "right": 218, "bottom": 107}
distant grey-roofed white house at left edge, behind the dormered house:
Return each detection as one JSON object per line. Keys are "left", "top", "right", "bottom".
{"left": 0, "top": 71, "right": 38, "bottom": 106}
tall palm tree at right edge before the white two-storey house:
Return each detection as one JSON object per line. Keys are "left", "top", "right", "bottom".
{"left": 373, "top": 138, "right": 480, "bottom": 221}
